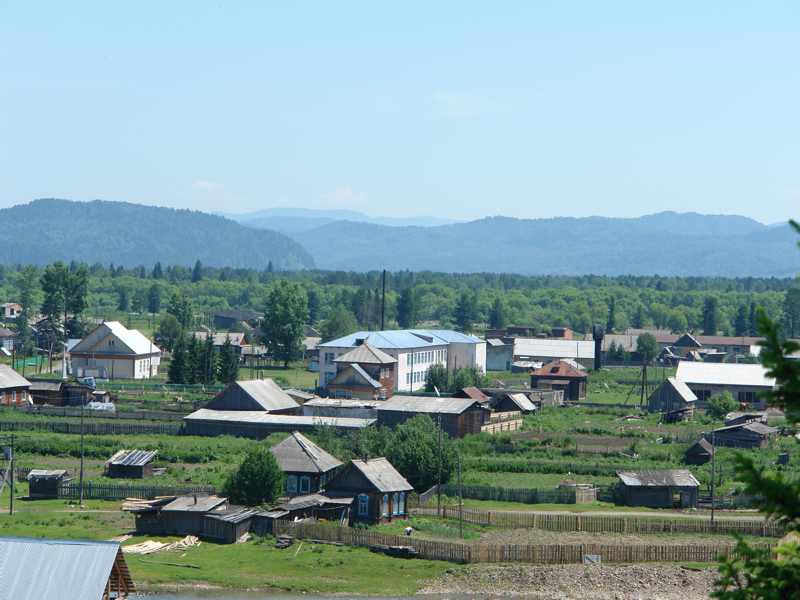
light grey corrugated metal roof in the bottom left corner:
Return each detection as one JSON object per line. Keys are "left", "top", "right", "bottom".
{"left": 0, "top": 537, "right": 126, "bottom": 600}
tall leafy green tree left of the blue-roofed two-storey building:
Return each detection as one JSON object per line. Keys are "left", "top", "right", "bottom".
{"left": 261, "top": 281, "right": 308, "bottom": 366}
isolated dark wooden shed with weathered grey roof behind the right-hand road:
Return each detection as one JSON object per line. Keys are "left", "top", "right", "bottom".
{"left": 617, "top": 469, "right": 700, "bottom": 508}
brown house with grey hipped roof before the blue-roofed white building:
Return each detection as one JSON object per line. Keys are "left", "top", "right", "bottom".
{"left": 325, "top": 342, "right": 397, "bottom": 400}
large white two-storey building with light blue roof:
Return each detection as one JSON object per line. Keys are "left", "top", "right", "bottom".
{"left": 319, "top": 329, "right": 486, "bottom": 392}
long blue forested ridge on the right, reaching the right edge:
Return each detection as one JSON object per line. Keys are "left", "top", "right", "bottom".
{"left": 298, "top": 213, "right": 797, "bottom": 277}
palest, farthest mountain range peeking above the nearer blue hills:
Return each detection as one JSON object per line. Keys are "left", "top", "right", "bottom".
{"left": 222, "top": 208, "right": 458, "bottom": 234}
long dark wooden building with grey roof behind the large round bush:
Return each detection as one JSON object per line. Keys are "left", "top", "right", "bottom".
{"left": 378, "top": 396, "right": 491, "bottom": 437}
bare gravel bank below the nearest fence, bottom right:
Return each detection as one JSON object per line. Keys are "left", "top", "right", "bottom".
{"left": 420, "top": 565, "right": 717, "bottom": 600}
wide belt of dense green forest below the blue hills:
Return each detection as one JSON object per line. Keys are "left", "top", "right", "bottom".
{"left": 0, "top": 261, "right": 800, "bottom": 335}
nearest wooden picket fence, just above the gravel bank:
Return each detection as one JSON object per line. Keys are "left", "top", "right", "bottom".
{"left": 273, "top": 520, "right": 771, "bottom": 564}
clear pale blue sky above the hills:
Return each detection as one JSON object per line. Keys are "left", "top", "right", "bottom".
{"left": 0, "top": 0, "right": 800, "bottom": 223}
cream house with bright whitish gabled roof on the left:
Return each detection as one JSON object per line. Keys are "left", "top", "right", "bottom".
{"left": 69, "top": 321, "right": 161, "bottom": 379}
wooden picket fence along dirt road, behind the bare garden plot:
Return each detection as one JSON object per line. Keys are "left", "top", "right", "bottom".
{"left": 411, "top": 506, "right": 786, "bottom": 537}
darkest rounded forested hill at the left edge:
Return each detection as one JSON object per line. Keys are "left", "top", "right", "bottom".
{"left": 0, "top": 199, "right": 314, "bottom": 269}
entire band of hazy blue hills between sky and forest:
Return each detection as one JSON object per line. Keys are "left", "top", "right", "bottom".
{"left": 0, "top": 200, "right": 796, "bottom": 277}
